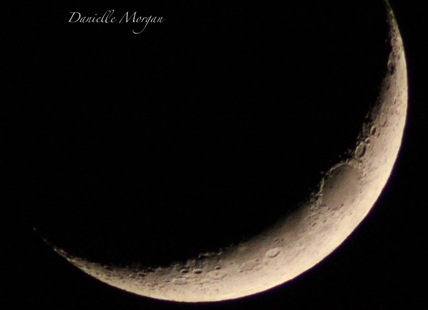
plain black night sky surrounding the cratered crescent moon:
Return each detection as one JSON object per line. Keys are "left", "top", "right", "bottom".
{"left": 0, "top": 0, "right": 428, "bottom": 309}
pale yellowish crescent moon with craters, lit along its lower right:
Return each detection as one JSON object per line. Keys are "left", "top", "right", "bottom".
{"left": 42, "top": 1, "right": 408, "bottom": 302}
